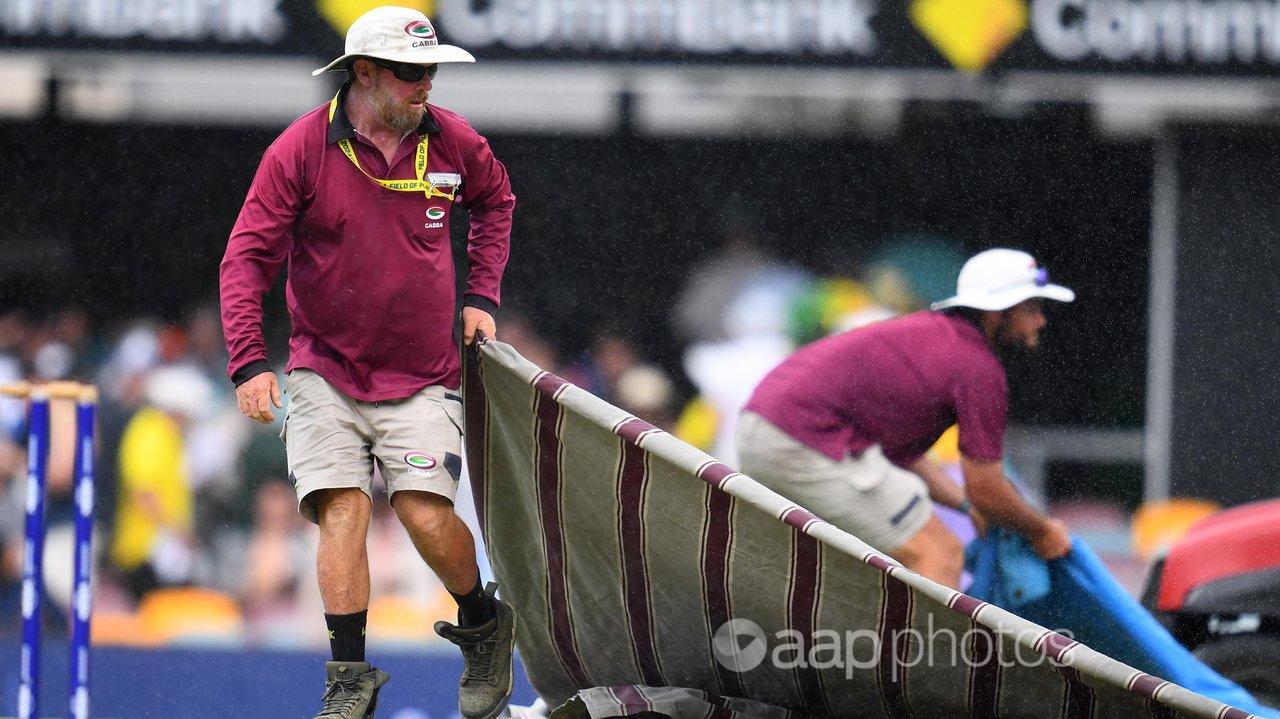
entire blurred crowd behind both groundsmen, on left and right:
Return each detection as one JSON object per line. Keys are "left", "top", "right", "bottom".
{"left": 0, "top": 232, "right": 964, "bottom": 646}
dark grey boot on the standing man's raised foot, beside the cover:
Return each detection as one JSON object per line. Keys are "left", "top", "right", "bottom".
{"left": 435, "top": 582, "right": 516, "bottom": 719}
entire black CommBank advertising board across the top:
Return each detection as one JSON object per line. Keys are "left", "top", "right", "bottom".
{"left": 0, "top": 0, "right": 1280, "bottom": 75}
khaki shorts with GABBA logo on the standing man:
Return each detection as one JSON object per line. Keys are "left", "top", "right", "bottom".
{"left": 280, "top": 368, "right": 462, "bottom": 522}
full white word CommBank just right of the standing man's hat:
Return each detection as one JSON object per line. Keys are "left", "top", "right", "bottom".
{"left": 438, "top": 0, "right": 878, "bottom": 56}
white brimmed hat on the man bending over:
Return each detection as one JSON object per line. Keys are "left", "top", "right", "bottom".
{"left": 932, "top": 249, "right": 1075, "bottom": 312}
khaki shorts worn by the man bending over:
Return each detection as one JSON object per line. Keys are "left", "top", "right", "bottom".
{"left": 736, "top": 412, "right": 933, "bottom": 553}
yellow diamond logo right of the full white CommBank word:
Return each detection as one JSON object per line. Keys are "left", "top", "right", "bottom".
{"left": 910, "top": 0, "right": 1028, "bottom": 74}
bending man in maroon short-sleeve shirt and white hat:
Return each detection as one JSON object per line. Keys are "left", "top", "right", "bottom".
{"left": 737, "top": 249, "right": 1075, "bottom": 587}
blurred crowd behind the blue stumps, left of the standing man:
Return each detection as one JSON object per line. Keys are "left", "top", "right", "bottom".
{"left": 0, "top": 306, "right": 335, "bottom": 638}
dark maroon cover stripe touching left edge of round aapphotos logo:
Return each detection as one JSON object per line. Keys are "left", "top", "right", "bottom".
{"left": 698, "top": 462, "right": 746, "bottom": 696}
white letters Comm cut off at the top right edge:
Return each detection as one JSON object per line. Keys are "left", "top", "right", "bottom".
{"left": 1032, "top": 0, "right": 1280, "bottom": 65}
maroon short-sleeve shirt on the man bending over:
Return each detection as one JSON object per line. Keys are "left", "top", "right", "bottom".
{"left": 746, "top": 312, "right": 1009, "bottom": 466}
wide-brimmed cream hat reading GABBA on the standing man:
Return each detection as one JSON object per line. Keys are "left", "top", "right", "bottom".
{"left": 311, "top": 5, "right": 476, "bottom": 75}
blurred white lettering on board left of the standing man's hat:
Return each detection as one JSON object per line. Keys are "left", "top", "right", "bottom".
{"left": 0, "top": 0, "right": 287, "bottom": 43}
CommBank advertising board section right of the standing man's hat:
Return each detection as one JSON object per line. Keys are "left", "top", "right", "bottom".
{"left": 436, "top": 0, "right": 1280, "bottom": 73}
